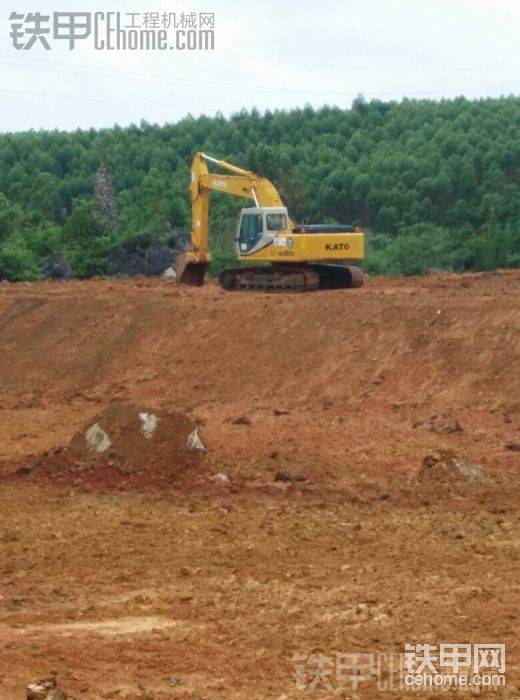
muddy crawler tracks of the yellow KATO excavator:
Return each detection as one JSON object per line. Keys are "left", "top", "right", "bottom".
{"left": 219, "top": 265, "right": 363, "bottom": 292}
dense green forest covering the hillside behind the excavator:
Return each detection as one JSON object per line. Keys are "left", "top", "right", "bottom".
{"left": 0, "top": 96, "right": 520, "bottom": 281}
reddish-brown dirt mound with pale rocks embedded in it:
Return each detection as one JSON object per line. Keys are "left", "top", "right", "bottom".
{"left": 2, "top": 400, "right": 204, "bottom": 489}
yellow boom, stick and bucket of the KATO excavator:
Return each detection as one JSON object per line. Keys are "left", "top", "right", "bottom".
{"left": 176, "top": 153, "right": 293, "bottom": 285}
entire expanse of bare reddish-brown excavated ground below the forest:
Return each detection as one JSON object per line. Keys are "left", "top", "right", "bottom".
{"left": 0, "top": 272, "right": 520, "bottom": 700}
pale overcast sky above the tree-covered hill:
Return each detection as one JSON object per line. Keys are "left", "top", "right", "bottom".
{"left": 0, "top": 0, "right": 520, "bottom": 132}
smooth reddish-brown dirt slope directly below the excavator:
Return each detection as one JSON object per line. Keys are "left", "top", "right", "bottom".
{"left": 0, "top": 273, "right": 520, "bottom": 405}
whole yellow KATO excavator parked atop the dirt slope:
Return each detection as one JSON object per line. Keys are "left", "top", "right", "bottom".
{"left": 176, "top": 153, "right": 364, "bottom": 292}
